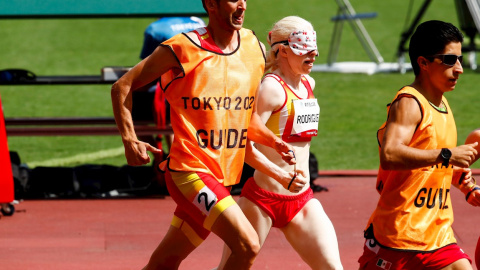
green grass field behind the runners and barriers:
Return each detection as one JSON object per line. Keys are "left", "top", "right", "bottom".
{"left": 0, "top": 0, "right": 480, "bottom": 170}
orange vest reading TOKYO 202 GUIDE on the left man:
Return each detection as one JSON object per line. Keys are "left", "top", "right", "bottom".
{"left": 160, "top": 29, "right": 265, "bottom": 186}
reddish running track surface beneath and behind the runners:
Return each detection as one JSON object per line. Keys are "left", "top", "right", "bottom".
{"left": 0, "top": 171, "right": 480, "bottom": 270}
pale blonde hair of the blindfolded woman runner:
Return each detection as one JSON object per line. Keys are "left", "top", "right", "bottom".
{"left": 265, "top": 16, "right": 313, "bottom": 72}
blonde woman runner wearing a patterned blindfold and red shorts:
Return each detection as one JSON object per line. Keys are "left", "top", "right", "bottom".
{"left": 218, "top": 16, "right": 343, "bottom": 269}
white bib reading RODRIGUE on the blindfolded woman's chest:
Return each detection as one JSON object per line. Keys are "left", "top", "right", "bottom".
{"left": 291, "top": 99, "right": 320, "bottom": 137}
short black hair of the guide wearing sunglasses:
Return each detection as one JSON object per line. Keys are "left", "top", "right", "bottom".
{"left": 408, "top": 20, "right": 463, "bottom": 76}
